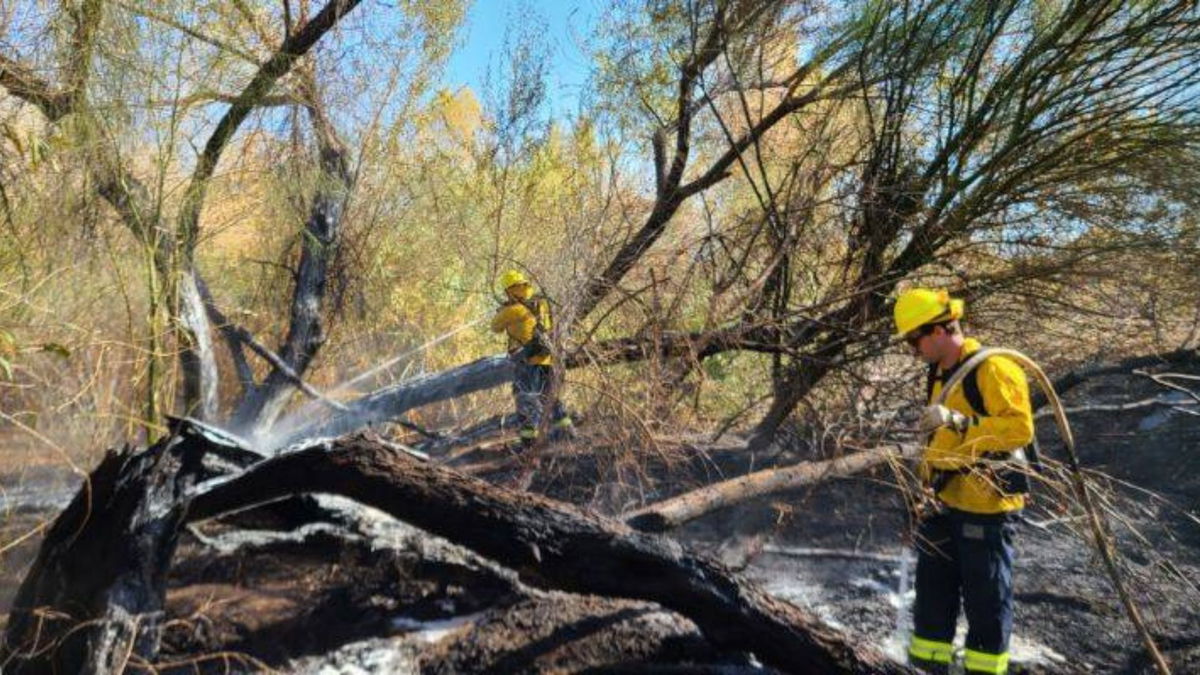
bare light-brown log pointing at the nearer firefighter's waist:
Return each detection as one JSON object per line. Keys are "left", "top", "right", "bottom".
{"left": 625, "top": 446, "right": 920, "bottom": 532}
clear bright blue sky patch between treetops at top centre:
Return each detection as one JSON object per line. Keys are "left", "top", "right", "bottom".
{"left": 443, "top": 0, "right": 604, "bottom": 118}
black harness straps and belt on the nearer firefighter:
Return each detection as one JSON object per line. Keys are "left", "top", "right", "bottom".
{"left": 925, "top": 348, "right": 1042, "bottom": 495}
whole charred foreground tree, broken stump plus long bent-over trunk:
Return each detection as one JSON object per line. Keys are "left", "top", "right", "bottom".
{"left": 2, "top": 425, "right": 907, "bottom": 673}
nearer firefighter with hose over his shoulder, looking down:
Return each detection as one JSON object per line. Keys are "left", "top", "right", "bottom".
{"left": 895, "top": 288, "right": 1033, "bottom": 674}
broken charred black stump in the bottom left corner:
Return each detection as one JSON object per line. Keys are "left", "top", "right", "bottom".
{"left": 0, "top": 432, "right": 209, "bottom": 675}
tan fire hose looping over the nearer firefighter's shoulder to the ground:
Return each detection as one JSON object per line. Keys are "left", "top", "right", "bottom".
{"left": 934, "top": 347, "right": 1170, "bottom": 675}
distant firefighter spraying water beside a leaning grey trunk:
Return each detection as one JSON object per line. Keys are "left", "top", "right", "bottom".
{"left": 492, "top": 269, "right": 574, "bottom": 448}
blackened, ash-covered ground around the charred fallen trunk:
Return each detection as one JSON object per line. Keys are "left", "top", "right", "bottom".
{"left": 0, "top": 369, "right": 1200, "bottom": 675}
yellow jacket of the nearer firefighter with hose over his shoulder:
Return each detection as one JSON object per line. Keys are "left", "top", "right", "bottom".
{"left": 919, "top": 338, "right": 1033, "bottom": 513}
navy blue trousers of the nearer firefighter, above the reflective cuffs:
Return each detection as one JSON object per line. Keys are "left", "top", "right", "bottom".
{"left": 913, "top": 509, "right": 1014, "bottom": 655}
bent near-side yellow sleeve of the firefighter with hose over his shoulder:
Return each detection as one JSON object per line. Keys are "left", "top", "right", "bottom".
{"left": 962, "top": 357, "right": 1033, "bottom": 456}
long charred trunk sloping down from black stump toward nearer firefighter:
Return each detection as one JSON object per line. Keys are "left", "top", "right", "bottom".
{"left": 188, "top": 437, "right": 907, "bottom": 673}
